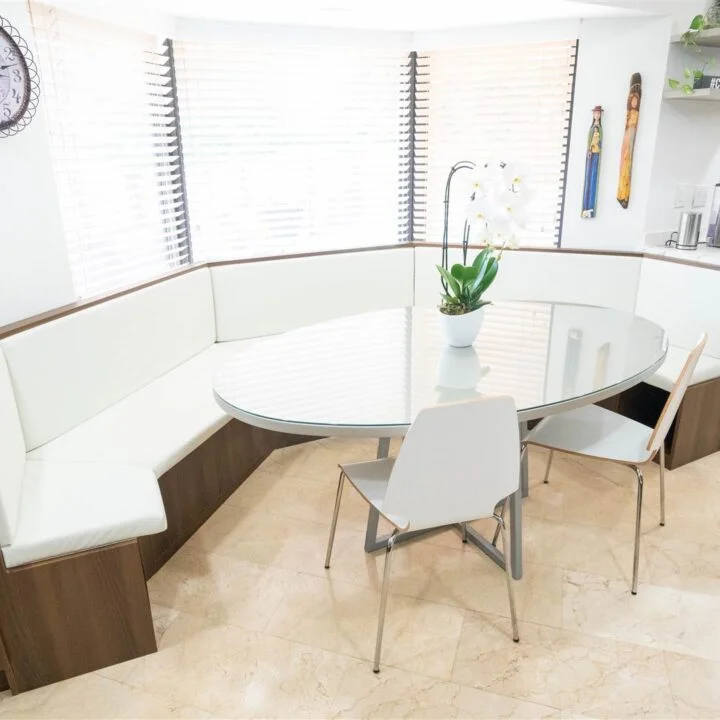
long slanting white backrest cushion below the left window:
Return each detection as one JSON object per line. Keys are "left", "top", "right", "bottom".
{"left": 0, "top": 268, "right": 215, "bottom": 449}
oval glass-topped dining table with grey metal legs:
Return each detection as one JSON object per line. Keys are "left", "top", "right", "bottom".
{"left": 213, "top": 302, "right": 667, "bottom": 578}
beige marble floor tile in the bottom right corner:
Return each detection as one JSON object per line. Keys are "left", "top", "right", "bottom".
{"left": 665, "top": 653, "right": 720, "bottom": 718}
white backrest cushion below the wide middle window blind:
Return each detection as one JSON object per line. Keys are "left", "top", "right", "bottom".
{"left": 211, "top": 247, "right": 414, "bottom": 342}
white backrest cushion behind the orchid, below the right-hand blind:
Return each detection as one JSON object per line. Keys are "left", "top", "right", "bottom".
{"left": 415, "top": 247, "right": 642, "bottom": 312}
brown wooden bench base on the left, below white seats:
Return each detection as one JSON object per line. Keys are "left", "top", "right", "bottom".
{"left": 0, "top": 420, "right": 314, "bottom": 693}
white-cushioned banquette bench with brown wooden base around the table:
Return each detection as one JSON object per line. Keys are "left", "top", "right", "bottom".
{"left": 0, "top": 246, "right": 720, "bottom": 692}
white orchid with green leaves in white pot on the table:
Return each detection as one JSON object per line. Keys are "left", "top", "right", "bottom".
{"left": 437, "top": 161, "right": 530, "bottom": 347}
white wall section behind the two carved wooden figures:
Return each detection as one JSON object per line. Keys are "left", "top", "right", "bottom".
{"left": 562, "top": 18, "right": 671, "bottom": 250}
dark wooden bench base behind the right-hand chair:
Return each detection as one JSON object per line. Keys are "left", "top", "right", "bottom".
{"left": 600, "top": 378, "right": 720, "bottom": 470}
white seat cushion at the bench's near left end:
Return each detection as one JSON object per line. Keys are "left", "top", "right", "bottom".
{"left": 2, "top": 462, "right": 167, "bottom": 567}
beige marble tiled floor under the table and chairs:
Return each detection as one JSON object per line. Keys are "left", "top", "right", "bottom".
{"left": 0, "top": 440, "right": 720, "bottom": 718}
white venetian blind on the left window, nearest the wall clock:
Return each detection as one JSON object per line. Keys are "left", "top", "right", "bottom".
{"left": 31, "top": 2, "right": 189, "bottom": 297}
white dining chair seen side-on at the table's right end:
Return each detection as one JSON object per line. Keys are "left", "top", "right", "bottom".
{"left": 525, "top": 333, "right": 707, "bottom": 595}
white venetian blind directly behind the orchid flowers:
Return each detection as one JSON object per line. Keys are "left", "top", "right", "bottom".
{"left": 414, "top": 40, "right": 577, "bottom": 246}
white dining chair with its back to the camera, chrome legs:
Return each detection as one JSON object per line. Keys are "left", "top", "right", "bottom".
{"left": 325, "top": 396, "right": 520, "bottom": 673}
